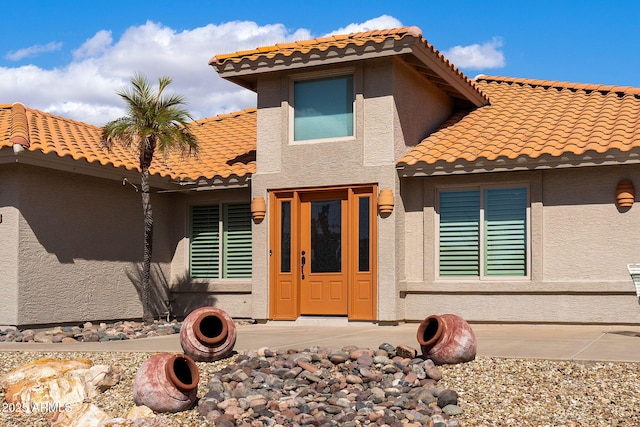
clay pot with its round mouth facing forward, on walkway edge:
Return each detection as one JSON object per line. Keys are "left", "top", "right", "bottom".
{"left": 180, "top": 307, "right": 236, "bottom": 362}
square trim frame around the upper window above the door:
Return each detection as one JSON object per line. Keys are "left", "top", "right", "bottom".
{"left": 287, "top": 67, "right": 358, "bottom": 145}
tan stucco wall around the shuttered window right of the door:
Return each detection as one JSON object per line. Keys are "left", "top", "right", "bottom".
{"left": 401, "top": 165, "right": 640, "bottom": 323}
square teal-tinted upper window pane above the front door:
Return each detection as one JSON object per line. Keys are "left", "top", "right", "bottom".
{"left": 293, "top": 75, "right": 354, "bottom": 141}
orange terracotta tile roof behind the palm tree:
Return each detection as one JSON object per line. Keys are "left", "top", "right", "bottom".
{"left": 0, "top": 104, "right": 256, "bottom": 181}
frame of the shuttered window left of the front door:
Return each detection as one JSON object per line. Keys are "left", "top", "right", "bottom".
{"left": 185, "top": 200, "right": 253, "bottom": 283}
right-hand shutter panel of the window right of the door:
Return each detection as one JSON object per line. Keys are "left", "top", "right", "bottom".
{"left": 484, "top": 188, "right": 527, "bottom": 276}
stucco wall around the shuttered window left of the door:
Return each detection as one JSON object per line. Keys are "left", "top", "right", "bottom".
{"left": 169, "top": 188, "right": 255, "bottom": 318}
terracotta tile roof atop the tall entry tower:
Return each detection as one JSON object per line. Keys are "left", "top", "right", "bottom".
{"left": 209, "top": 26, "right": 489, "bottom": 105}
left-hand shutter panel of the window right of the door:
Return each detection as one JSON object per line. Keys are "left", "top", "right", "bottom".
{"left": 440, "top": 190, "right": 480, "bottom": 276}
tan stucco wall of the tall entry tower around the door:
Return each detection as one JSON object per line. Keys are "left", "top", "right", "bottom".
{"left": 251, "top": 58, "right": 451, "bottom": 321}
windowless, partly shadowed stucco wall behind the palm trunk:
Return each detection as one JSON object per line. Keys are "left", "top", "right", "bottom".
{"left": 3, "top": 165, "right": 179, "bottom": 325}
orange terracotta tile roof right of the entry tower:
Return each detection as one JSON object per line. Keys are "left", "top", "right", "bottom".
{"left": 398, "top": 76, "right": 640, "bottom": 169}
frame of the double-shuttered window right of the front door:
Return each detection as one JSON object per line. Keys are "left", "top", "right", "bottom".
{"left": 434, "top": 182, "right": 532, "bottom": 282}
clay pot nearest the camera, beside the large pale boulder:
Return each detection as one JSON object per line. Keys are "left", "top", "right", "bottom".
{"left": 133, "top": 353, "right": 200, "bottom": 412}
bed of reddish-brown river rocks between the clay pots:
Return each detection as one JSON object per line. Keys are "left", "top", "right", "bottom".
{"left": 198, "top": 344, "right": 461, "bottom": 427}
